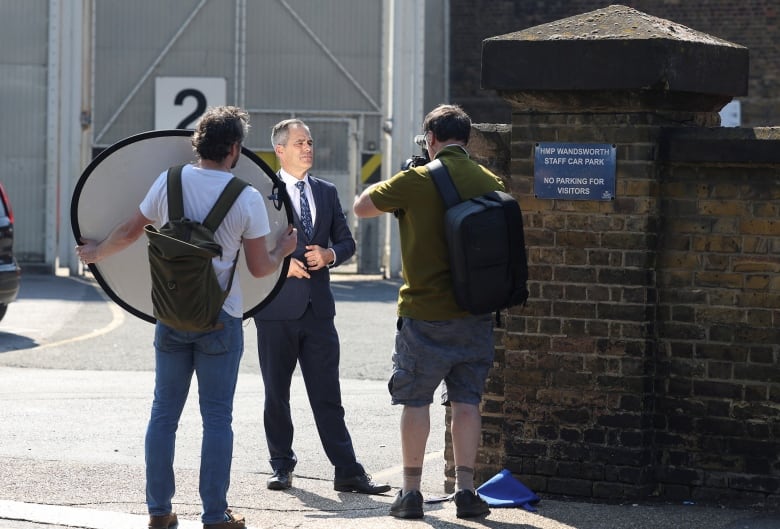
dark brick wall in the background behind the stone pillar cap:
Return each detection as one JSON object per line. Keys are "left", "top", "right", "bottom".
{"left": 450, "top": 0, "right": 780, "bottom": 127}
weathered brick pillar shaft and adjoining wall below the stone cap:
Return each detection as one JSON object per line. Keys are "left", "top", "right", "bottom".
{"left": 445, "top": 112, "right": 780, "bottom": 507}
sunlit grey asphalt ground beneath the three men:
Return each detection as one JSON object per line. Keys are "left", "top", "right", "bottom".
{"left": 0, "top": 275, "right": 780, "bottom": 529}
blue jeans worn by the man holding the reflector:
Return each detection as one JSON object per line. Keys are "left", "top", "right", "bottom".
{"left": 145, "top": 311, "right": 244, "bottom": 524}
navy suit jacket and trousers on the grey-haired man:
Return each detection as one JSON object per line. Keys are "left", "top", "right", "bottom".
{"left": 254, "top": 175, "right": 362, "bottom": 477}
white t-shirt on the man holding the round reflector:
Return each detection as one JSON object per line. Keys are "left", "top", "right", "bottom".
{"left": 139, "top": 164, "right": 271, "bottom": 318}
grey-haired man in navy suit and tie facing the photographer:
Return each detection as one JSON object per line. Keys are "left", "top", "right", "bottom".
{"left": 254, "top": 119, "right": 390, "bottom": 494}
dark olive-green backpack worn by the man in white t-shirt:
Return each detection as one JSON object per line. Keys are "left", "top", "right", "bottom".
{"left": 144, "top": 165, "right": 249, "bottom": 332}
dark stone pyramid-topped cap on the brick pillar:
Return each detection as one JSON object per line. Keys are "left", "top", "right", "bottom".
{"left": 482, "top": 5, "right": 748, "bottom": 106}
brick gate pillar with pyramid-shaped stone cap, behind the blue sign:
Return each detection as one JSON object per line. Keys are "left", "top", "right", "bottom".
{"left": 478, "top": 6, "right": 748, "bottom": 498}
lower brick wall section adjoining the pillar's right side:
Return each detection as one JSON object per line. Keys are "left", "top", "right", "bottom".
{"left": 654, "top": 130, "right": 780, "bottom": 505}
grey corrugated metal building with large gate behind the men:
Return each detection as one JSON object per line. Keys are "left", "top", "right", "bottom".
{"left": 0, "top": 0, "right": 448, "bottom": 273}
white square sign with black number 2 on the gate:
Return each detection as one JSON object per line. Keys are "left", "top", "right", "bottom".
{"left": 154, "top": 77, "right": 227, "bottom": 130}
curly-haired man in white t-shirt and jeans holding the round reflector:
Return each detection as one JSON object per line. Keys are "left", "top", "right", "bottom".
{"left": 76, "top": 106, "right": 298, "bottom": 529}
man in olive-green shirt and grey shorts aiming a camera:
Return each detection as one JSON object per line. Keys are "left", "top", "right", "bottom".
{"left": 354, "top": 105, "right": 504, "bottom": 518}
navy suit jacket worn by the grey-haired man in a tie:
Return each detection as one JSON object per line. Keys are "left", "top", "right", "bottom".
{"left": 254, "top": 174, "right": 355, "bottom": 320}
